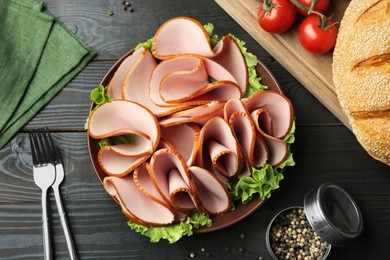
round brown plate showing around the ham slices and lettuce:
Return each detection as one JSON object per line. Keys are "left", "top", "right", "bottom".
{"left": 87, "top": 50, "right": 282, "bottom": 233}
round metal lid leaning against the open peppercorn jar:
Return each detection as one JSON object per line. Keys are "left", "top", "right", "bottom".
{"left": 304, "top": 183, "right": 363, "bottom": 246}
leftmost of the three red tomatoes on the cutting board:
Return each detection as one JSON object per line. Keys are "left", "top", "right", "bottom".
{"left": 257, "top": 0, "right": 296, "bottom": 33}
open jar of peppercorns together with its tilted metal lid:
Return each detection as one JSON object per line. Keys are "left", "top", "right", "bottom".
{"left": 266, "top": 183, "right": 363, "bottom": 260}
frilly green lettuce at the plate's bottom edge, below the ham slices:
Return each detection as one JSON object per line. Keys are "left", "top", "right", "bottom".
{"left": 127, "top": 212, "right": 212, "bottom": 244}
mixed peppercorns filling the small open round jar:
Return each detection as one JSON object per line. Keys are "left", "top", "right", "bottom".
{"left": 270, "top": 208, "right": 329, "bottom": 260}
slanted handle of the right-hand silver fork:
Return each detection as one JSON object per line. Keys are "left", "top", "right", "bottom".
{"left": 53, "top": 185, "right": 78, "bottom": 260}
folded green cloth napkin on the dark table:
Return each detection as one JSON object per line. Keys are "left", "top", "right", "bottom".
{"left": 0, "top": 0, "right": 96, "bottom": 148}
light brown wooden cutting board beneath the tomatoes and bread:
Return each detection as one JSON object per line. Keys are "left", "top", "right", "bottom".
{"left": 215, "top": 0, "right": 350, "bottom": 128}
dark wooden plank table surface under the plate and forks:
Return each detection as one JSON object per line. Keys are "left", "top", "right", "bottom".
{"left": 0, "top": 0, "right": 390, "bottom": 259}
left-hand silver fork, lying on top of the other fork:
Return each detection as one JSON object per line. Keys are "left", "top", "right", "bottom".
{"left": 29, "top": 129, "right": 56, "bottom": 260}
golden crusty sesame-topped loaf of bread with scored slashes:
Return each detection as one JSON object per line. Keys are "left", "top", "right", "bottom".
{"left": 333, "top": 0, "right": 390, "bottom": 165}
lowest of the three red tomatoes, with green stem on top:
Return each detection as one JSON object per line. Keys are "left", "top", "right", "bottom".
{"left": 298, "top": 14, "right": 337, "bottom": 54}
